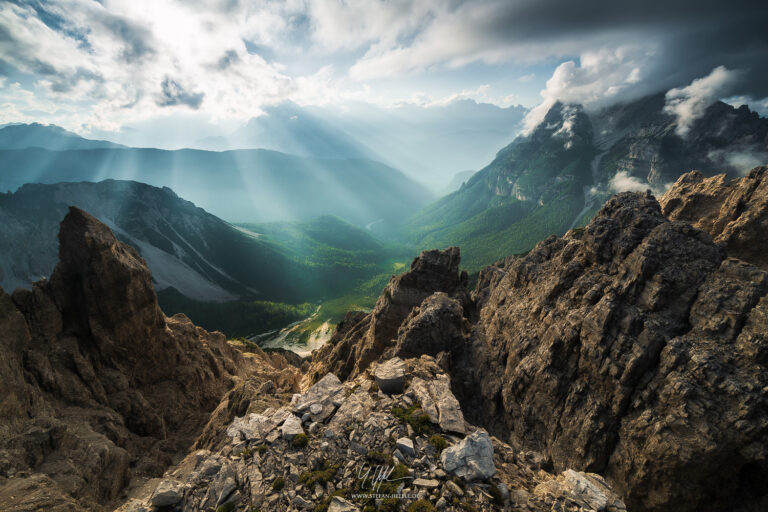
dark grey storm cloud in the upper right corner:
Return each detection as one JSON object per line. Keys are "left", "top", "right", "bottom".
{"left": 474, "top": 0, "right": 768, "bottom": 97}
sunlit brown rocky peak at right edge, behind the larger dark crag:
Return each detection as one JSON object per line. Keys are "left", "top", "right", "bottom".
{"left": 659, "top": 166, "right": 768, "bottom": 270}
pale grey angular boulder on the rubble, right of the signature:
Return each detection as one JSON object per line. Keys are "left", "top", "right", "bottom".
{"left": 440, "top": 430, "right": 496, "bottom": 482}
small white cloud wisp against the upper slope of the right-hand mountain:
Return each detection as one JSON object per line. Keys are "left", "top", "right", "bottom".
{"left": 664, "top": 66, "right": 741, "bottom": 137}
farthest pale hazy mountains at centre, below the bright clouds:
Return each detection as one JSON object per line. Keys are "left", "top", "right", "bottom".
{"left": 193, "top": 100, "right": 527, "bottom": 192}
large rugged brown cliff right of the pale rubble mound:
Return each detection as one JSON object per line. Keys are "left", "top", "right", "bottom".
{"left": 313, "top": 178, "right": 768, "bottom": 511}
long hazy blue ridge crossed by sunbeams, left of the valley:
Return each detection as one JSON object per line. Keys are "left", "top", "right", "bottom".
{"left": 0, "top": 125, "right": 431, "bottom": 228}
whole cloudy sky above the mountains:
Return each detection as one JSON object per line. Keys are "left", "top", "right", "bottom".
{"left": 0, "top": 0, "right": 768, "bottom": 140}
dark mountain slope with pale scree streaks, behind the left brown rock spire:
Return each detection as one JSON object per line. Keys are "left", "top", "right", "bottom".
{"left": 0, "top": 180, "right": 408, "bottom": 332}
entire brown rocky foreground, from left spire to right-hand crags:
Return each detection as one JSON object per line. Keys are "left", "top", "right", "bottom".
{"left": 0, "top": 169, "right": 768, "bottom": 512}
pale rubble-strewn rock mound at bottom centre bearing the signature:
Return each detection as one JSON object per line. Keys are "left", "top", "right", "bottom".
{"left": 121, "top": 356, "right": 624, "bottom": 512}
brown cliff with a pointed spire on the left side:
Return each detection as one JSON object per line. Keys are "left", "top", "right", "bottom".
{"left": 0, "top": 208, "right": 298, "bottom": 510}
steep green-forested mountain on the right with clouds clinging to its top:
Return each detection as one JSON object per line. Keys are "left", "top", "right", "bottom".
{"left": 402, "top": 95, "right": 768, "bottom": 269}
